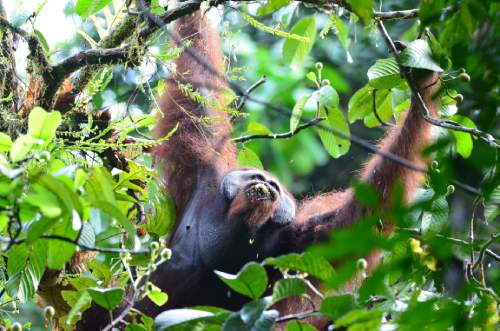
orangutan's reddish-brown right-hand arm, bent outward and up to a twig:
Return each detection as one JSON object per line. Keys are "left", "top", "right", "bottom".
{"left": 272, "top": 70, "right": 440, "bottom": 253}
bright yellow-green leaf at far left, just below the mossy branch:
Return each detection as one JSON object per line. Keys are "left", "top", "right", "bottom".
{"left": 28, "top": 107, "right": 62, "bottom": 144}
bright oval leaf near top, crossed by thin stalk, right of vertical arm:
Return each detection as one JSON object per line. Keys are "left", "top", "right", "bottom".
{"left": 283, "top": 16, "right": 316, "bottom": 70}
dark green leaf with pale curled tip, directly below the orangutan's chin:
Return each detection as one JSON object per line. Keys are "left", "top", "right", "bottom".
{"left": 215, "top": 262, "right": 267, "bottom": 299}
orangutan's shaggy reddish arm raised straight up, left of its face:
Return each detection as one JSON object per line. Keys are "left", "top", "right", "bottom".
{"left": 154, "top": 11, "right": 236, "bottom": 212}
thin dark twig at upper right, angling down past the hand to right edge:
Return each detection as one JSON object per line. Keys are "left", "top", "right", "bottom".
{"left": 376, "top": 20, "right": 499, "bottom": 148}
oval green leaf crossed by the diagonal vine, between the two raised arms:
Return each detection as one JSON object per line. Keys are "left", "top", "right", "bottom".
{"left": 316, "top": 108, "right": 351, "bottom": 158}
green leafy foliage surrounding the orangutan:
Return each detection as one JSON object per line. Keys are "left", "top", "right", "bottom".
{"left": 0, "top": 0, "right": 500, "bottom": 330}
